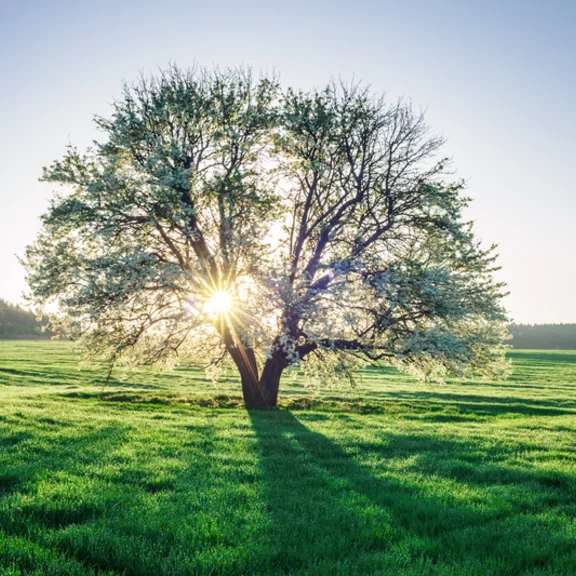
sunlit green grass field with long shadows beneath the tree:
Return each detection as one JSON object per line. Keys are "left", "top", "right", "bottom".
{"left": 0, "top": 341, "right": 576, "bottom": 576}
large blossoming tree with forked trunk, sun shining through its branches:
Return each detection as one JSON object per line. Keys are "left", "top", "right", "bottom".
{"left": 24, "top": 67, "right": 505, "bottom": 406}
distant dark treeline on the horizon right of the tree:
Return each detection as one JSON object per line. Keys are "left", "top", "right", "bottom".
{"left": 507, "top": 324, "right": 576, "bottom": 350}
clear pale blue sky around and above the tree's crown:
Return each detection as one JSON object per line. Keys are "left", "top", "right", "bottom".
{"left": 0, "top": 0, "right": 576, "bottom": 323}
